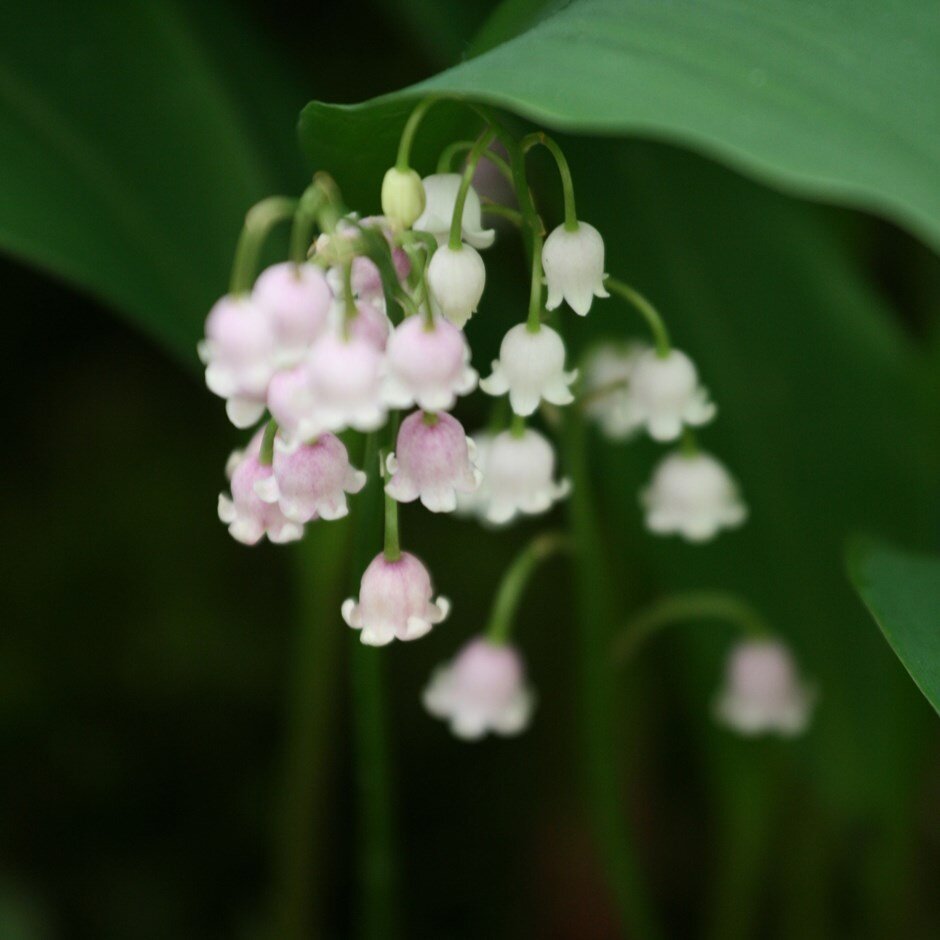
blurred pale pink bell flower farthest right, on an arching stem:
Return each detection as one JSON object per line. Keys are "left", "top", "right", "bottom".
{"left": 715, "top": 639, "right": 816, "bottom": 736}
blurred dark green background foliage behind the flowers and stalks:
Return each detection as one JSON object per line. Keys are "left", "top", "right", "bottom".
{"left": 0, "top": 0, "right": 940, "bottom": 940}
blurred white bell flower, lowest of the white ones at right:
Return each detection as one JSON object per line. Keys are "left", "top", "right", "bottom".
{"left": 640, "top": 452, "right": 747, "bottom": 542}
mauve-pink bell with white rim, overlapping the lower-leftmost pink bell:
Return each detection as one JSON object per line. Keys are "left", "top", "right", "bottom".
{"left": 255, "top": 434, "right": 366, "bottom": 522}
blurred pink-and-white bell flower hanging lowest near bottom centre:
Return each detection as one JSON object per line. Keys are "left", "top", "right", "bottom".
{"left": 423, "top": 637, "right": 535, "bottom": 740}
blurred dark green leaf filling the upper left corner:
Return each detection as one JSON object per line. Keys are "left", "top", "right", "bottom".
{"left": 0, "top": 0, "right": 300, "bottom": 357}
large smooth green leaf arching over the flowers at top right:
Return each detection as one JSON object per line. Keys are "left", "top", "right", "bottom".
{"left": 300, "top": 0, "right": 940, "bottom": 247}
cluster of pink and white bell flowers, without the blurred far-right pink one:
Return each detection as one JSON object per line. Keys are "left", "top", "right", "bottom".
{"left": 199, "top": 105, "right": 812, "bottom": 738}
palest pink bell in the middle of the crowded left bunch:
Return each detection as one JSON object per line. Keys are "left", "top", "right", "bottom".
{"left": 306, "top": 333, "right": 387, "bottom": 434}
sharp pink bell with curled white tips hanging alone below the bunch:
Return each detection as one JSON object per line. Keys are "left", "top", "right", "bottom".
{"left": 343, "top": 552, "right": 450, "bottom": 646}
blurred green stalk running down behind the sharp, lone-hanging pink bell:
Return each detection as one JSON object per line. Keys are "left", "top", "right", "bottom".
{"left": 350, "top": 434, "right": 399, "bottom": 940}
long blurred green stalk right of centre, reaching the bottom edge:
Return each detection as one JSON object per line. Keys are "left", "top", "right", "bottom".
{"left": 564, "top": 409, "right": 660, "bottom": 940}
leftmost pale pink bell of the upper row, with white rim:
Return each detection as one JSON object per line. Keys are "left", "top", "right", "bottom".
{"left": 199, "top": 294, "right": 277, "bottom": 428}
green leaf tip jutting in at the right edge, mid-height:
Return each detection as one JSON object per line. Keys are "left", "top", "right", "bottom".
{"left": 848, "top": 541, "right": 940, "bottom": 712}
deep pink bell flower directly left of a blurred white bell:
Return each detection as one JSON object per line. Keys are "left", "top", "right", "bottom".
{"left": 385, "top": 411, "right": 480, "bottom": 512}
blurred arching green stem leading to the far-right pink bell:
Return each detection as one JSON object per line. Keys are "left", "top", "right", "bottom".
{"left": 613, "top": 591, "right": 773, "bottom": 663}
